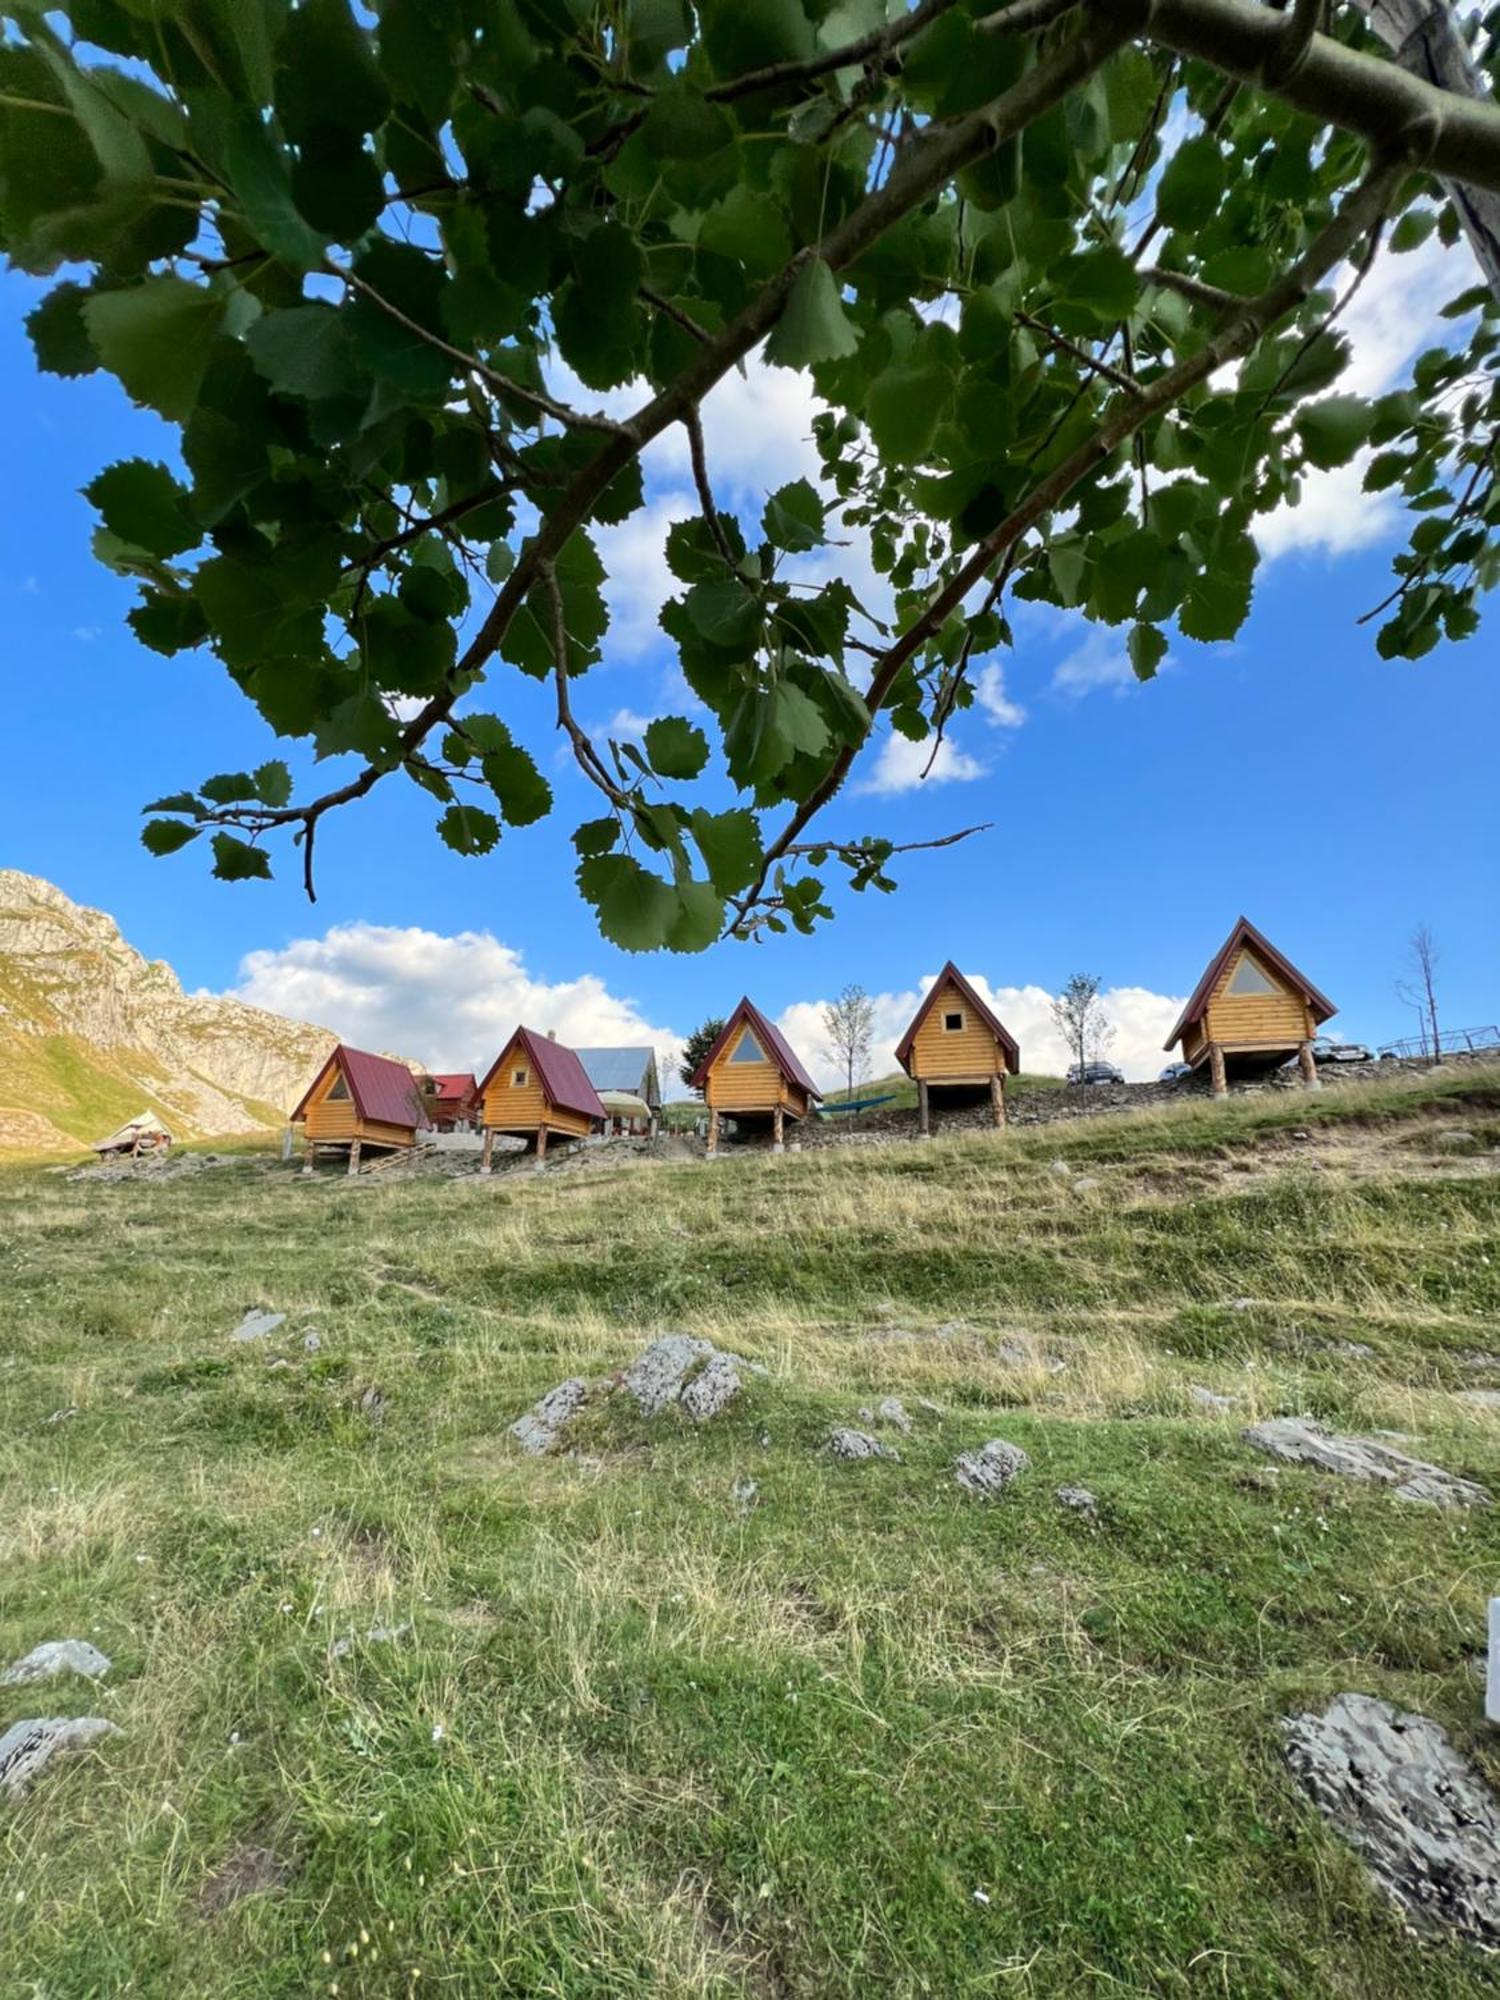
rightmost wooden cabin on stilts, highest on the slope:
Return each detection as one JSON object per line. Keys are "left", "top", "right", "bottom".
{"left": 1164, "top": 916, "right": 1336, "bottom": 1098}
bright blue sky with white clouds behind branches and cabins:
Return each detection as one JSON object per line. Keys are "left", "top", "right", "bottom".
{"left": 0, "top": 240, "right": 1500, "bottom": 1074}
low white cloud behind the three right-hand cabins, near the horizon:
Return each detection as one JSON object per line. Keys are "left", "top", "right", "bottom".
{"left": 776, "top": 966, "right": 1182, "bottom": 1086}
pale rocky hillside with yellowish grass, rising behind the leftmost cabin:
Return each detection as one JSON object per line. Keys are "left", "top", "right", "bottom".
{"left": 0, "top": 868, "right": 334, "bottom": 1152}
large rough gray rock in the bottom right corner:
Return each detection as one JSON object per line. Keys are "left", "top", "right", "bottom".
{"left": 1282, "top": 1694, "right": 1500, "bottom": 1948}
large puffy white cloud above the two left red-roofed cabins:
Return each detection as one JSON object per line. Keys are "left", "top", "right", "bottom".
{"left": 230, "top": 924, "right": 678, "bottom": 1074}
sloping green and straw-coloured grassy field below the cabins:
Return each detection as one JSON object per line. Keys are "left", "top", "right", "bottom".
{"left": 0, "top": 1070, "right": 1500, "bottom": 2000}
